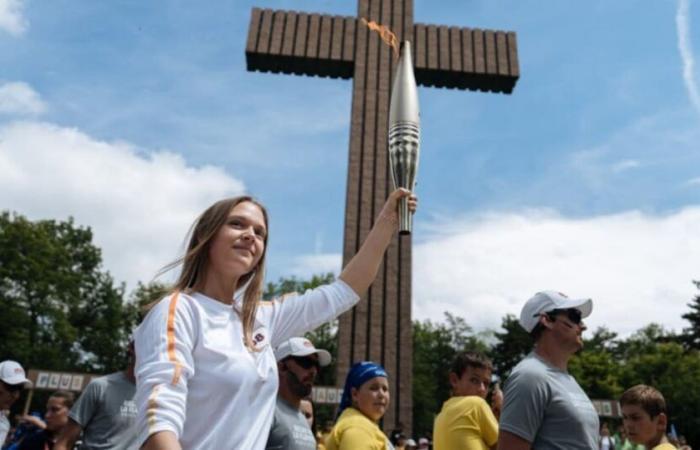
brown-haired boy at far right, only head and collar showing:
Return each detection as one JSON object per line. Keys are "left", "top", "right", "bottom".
{"left": 620, "top": 384, "right": 676, "bottom": 450}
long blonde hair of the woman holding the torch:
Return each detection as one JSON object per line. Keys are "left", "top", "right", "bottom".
{"left": 161, "top": 196, "right": 269, "bottom": 350}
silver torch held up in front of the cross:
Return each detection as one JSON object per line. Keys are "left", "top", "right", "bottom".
{"left": 389, "top": 41, "right": 420, "bottom": 234}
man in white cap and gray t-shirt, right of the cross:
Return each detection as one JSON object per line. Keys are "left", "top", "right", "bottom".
{"left": 498, "top": 291, "right": 600, "bottom": 450}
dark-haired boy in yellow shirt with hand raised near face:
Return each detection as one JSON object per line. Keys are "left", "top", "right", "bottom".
{"left": 433, "top": 352, "right": 503, "bottom": 450}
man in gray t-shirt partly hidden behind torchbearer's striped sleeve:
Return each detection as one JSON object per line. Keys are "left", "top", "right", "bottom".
{"left": 54, "top": 347, "right": 138, "bottom": 450}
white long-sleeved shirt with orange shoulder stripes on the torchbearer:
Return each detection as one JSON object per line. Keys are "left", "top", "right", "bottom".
{"left": 134, "top": 280, "right": 359, "bottom": 450}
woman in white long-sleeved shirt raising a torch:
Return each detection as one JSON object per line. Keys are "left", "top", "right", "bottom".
{"left": 135, "top": 189, "right": 417, "bottom": 450}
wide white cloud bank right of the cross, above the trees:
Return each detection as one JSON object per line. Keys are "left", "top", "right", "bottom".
{"left": 413, "top": 207, "right": 700, "bottom": 334}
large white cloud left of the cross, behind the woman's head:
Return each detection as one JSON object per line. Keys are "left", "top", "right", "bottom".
{"left": 0, "top": 122, "right": 244, "bottom": 287}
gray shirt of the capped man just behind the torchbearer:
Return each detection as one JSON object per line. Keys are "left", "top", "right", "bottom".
{"left": 265, "top": 396, "right": 316, "bottom": 450}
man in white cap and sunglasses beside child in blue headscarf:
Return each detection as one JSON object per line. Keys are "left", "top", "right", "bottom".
{"left": 266, "top": 337, "right": 331, "bottom": 450}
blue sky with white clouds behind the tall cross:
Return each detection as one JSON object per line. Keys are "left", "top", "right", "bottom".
{"left": 0, "top": 0, "right": 700, "bottom": 333}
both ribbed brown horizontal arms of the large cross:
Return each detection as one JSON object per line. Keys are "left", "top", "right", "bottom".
{"left": 246, "top": 8, "right": 520, "bottom": 94}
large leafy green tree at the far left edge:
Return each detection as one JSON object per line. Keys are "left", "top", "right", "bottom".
{"left": 0, "top": 212, "right": 132, "bottom": 373}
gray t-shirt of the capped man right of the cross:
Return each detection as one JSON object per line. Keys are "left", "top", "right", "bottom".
{"left": 499, "top": 352, "right": 600, "bottom": 450}
